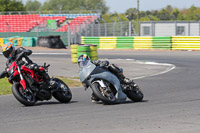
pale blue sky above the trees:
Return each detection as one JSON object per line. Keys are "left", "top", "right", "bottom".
{"left": 22, "top": 0, "right": 200, "bottom": 13}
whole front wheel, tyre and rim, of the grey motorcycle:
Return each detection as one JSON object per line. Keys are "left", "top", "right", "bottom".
{"left": 91, "top": 81, "right": 116, "bottom": 104}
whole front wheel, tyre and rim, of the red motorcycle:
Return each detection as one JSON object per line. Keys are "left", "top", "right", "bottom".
{"left": 12, "top": 83, "right": 36, "bottom": 106}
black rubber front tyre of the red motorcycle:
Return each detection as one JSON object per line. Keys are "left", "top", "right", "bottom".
{"left": 12, "top": 83, "right": 36, "bottom": 106}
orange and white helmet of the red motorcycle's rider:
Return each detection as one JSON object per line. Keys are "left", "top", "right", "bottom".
{"left": 2, "top": 42, "right": 15, "bottom": 59}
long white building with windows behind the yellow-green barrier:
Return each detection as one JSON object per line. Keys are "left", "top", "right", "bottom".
{"left": 140, "top": 21, "right": 200, "bottom": 36}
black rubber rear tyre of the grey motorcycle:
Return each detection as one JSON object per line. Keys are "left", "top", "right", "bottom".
{"left": 125, "top": 86, "right": 144, "bottom": 102}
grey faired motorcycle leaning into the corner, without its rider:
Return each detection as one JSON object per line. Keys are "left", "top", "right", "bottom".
{"left": 79, "top": 57, "right": 144, "bottom": 104}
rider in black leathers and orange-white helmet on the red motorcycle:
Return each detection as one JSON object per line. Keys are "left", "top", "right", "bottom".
{"left": 2, "top": 42, "right": 55, "bottom": 91}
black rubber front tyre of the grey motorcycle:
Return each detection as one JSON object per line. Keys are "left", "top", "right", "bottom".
{"left": 91, "top": 83, "right": 116, "bottom": 105}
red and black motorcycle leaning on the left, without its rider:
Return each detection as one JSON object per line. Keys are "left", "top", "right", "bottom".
{"left": 0, "top": 52, "right": 72, "bottom": 106}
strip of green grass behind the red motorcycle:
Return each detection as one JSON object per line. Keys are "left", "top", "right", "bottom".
{"left": 0, "top": 76, "right": 82, "bottom": 95}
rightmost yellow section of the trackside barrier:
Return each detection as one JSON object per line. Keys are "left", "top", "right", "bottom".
{"left": 172, "top": 36, "right": 200, "bottom": 50}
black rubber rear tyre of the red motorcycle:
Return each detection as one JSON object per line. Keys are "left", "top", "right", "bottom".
{"left": 53, "top": 78, "right": 72, "bottom": 103}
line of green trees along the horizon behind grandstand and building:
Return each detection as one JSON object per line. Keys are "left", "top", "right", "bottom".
{"left": 0, "top": 0, "right": 200, "bottom": 22}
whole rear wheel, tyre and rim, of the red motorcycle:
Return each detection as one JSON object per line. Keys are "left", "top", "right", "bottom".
{"left": 53, "top": 78, "right": 72, "bottom": 103}
